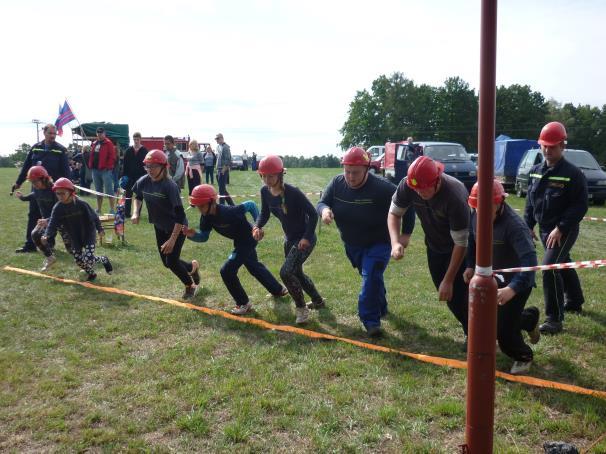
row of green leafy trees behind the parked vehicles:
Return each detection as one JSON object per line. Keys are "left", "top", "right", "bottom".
{"left": 339, "top": 72, "right": 606, "bottom": 163}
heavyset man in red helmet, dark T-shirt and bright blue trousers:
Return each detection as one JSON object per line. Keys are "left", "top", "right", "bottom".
{"left": 316, "top": 147, "right": 414, "bottom": 336}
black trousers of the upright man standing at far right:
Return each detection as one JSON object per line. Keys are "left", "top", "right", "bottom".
{"left": 540, "top": 225, "right": 585, "bottom": 322}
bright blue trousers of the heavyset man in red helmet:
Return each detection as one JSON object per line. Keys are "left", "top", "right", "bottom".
{"left": 345, "top": 243, "right": 391, "bottom": 329}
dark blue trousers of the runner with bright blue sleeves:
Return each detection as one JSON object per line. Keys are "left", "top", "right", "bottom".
{"left": 221, "top": 245, "right": 282, "bottom": 306}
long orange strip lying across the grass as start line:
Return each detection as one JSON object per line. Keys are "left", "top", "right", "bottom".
{"left": 3, "top": 266, "right": 606, "bottom": 399}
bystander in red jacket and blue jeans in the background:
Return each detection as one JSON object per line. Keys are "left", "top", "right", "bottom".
{"left": 88, "top": 127, "right": 116, "bottom": 214}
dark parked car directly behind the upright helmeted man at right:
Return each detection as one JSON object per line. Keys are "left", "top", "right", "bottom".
{"left": 516, "top": 148, "right": 606, "bottom": 205}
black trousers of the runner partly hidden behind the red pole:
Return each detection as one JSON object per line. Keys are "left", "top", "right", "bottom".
{"left": 497, "top": 287, "right": 539, "bottom": 361}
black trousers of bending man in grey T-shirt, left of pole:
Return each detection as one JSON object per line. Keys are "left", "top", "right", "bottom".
{"left": 427, "top": 248, "right": 469, "bottom": 335}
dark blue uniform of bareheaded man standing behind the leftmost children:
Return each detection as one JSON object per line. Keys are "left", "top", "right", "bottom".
{"left": 15, "top": 141, "right": 70, "bottom": 251}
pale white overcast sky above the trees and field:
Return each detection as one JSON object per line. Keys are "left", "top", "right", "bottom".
{"left": 0, "top": 0, "right": 606, "bottom": 155}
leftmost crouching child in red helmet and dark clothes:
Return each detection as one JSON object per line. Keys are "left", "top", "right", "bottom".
{"left": 15, "top": 166, "right": 72, "bottom": 271}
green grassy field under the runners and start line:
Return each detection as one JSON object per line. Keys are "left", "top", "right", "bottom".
{"left": 0, "top": 169, "right": 606, "bottom": 453}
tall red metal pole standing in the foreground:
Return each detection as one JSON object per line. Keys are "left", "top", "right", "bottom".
{"left": 465, "top": 0, "right": 497, "bottom": 454}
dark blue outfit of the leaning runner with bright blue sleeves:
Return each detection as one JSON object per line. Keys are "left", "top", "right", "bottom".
{"left": 190, "top": 201, "right": 282, "bottom": 306}
